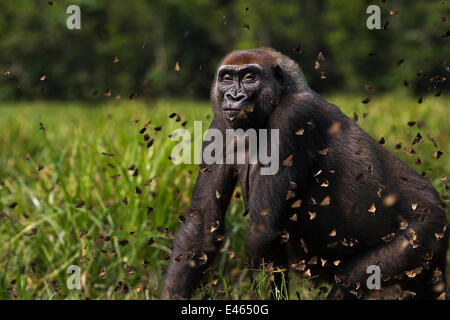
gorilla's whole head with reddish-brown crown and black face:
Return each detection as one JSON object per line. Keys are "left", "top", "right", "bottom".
{"left": 211, "top": 49, "right": 285, "bottom": 129}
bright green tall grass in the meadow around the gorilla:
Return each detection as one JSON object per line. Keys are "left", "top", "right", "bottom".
{"left": 0, "top": 94, "right": 450, "bottom": 299}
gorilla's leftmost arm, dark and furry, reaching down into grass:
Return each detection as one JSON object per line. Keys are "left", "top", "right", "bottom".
{"left": 161, "top": 159, "right": 236, "bottom": 299}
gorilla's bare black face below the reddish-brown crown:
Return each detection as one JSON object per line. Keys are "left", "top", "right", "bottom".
{"left": 216, "top": 64, "right": 279, "bottom": 128}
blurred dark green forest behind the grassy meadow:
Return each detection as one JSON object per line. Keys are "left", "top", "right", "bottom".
{"left": 0, "top": 0, "right": 450, "bottom": 100}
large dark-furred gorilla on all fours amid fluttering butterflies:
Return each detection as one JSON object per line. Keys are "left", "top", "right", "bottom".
{"left": 161, "top": 48, "right": 449, "bottom": 299}
